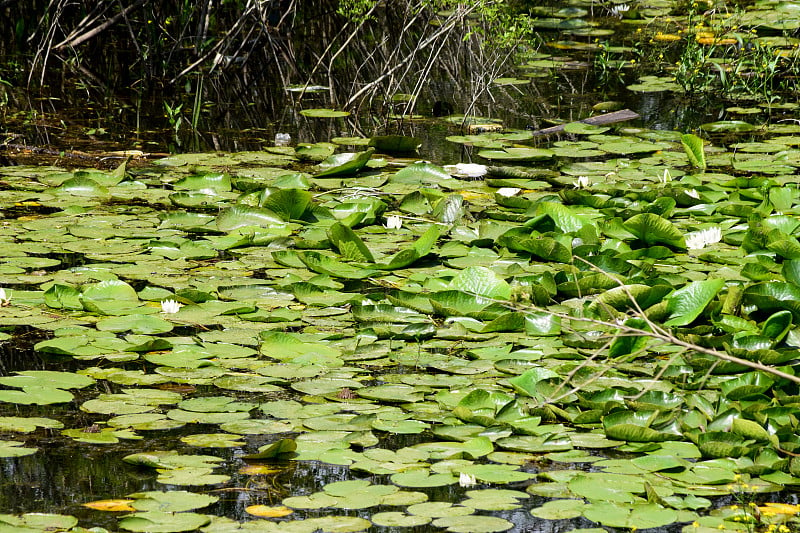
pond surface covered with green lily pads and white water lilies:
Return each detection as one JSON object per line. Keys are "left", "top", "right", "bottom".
{"left": 0, "top": 3, "right": 800, "bottom": 533}
